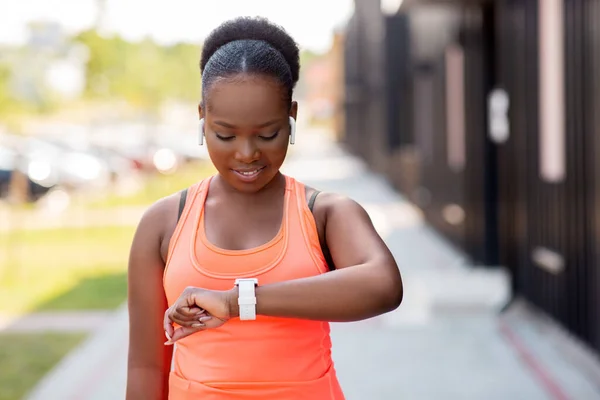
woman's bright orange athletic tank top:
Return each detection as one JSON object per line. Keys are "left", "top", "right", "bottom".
{"left": 164, "top": 176, "right": 344, "bottom": 400}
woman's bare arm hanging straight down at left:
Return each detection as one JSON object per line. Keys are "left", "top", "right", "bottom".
{"left": 126, "top": 198, "right": 176, "bottom": 400}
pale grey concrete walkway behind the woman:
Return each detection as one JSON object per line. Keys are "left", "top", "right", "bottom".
{"left": 29, "top": 129, "right": 600, "bottom": 400}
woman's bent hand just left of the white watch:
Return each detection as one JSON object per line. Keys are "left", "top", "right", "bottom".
{"left": 164, "top": 287, "right": 235, "bottom": 345}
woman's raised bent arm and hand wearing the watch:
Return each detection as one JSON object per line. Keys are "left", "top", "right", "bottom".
{"left": 165, "top": 193, "right": 403, "bottom": 344}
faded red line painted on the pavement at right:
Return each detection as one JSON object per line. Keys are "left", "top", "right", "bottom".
{"left": 500, "top": 321, "right": 569, "bottom": 400}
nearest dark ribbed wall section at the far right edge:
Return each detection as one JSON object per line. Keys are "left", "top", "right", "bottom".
{"left": 496, "top": 0, "right": 600, "bottom": 349}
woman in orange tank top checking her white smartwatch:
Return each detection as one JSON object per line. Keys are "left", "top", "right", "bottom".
{"left": 127, "top": 18, "right": 402, "bottom": 400}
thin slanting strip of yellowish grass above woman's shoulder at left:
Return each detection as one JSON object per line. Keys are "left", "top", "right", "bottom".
{"left": 86, "top": 161, "right": 216, "bottom": 208}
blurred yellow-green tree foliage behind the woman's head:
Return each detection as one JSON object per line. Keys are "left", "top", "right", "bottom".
{"left": 0, "top": 29, "right": 319, "bottom": 118}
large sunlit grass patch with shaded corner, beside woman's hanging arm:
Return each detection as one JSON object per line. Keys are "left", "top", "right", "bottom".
{"left": 0, "top": 227, "right": 135, "bottom": 313}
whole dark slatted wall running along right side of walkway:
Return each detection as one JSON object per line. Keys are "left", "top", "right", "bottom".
{"left": 346, "top": 0, "right": 600, "bottom": 350}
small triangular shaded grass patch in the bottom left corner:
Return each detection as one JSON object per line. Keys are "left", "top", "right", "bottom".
{"left": 0, "top": 333, "right": 85, "bottom": 400}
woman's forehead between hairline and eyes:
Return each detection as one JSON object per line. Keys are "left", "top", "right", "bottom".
{"left": 206, "top": 75, "right": 287, "bottom": 125}
